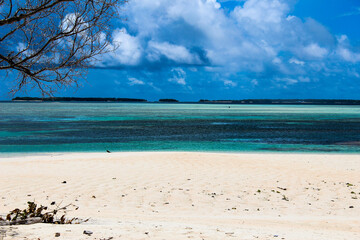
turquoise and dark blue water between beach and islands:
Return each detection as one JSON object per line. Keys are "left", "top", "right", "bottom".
{"left": 0, "top": 102, "right": 360, "bottom": 154}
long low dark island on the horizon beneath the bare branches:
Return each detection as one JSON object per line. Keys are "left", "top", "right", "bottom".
{"left": 12, "top": 97, "right": 147, "bottom": 102}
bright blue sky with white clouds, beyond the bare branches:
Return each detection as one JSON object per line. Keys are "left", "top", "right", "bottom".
{"left": 0, "top": 0, "right": 360, "bottom": 101}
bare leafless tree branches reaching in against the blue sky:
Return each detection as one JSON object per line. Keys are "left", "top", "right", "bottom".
{"left": 0, "top": 0, "right": 127, "bottom": 95}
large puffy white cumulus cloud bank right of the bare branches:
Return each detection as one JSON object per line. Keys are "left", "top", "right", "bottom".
{"left": 93, "top": 0, "right": 360, "bottom": 92}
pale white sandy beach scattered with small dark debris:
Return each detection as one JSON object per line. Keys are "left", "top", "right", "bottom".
{"left": 0, "top": 153, "right": 360, "bottom": 240}
